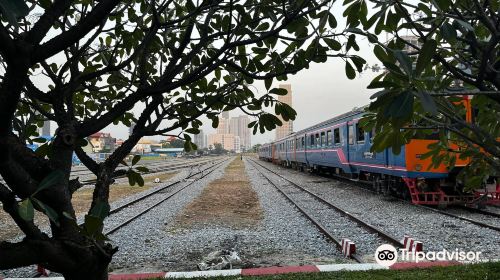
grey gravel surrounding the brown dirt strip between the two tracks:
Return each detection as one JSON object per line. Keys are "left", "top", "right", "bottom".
{"left": 107, "top": 159, "right": 347, "bottom": 272}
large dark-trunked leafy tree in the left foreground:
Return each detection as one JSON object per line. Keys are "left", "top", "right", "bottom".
{"left": 0, "top": 0, "right": 356, "bottom": 280}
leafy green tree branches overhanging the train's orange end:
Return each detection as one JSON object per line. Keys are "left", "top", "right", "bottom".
{"left": 344, "top": 0, "right": 500, "bottom": 188}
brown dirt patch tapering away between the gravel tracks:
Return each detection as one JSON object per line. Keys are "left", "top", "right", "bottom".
{"left": 173, "top": 157, "right": 263, "bottom": 228}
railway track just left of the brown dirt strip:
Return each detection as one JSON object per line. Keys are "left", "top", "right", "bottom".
{"left": 105, "top": 158, "right": 228, "bottom": 235}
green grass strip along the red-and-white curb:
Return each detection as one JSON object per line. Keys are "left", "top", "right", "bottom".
{"left": 146, "top": 262, "right": 500, "bottom": 280}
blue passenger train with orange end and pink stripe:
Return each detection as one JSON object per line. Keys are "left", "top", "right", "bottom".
{"left": 258, "top": 106, "right": 500, "bottom": 207}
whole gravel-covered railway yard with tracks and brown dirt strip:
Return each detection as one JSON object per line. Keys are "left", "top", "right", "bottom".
{"left": 0, "top": 156, "right": 500, "bottom": 277}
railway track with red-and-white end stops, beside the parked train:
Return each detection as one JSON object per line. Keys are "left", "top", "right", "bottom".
{"left": 248, "top": 159, "right": 404, "bottom": 263}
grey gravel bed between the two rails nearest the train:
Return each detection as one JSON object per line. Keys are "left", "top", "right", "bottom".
{"left": 249, "top": 160, "right": 387, "bottom": 261}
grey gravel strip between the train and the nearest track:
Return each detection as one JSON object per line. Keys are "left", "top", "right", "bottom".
{"left": 260, "top": 161, "right": 500, "bottom": 259}
